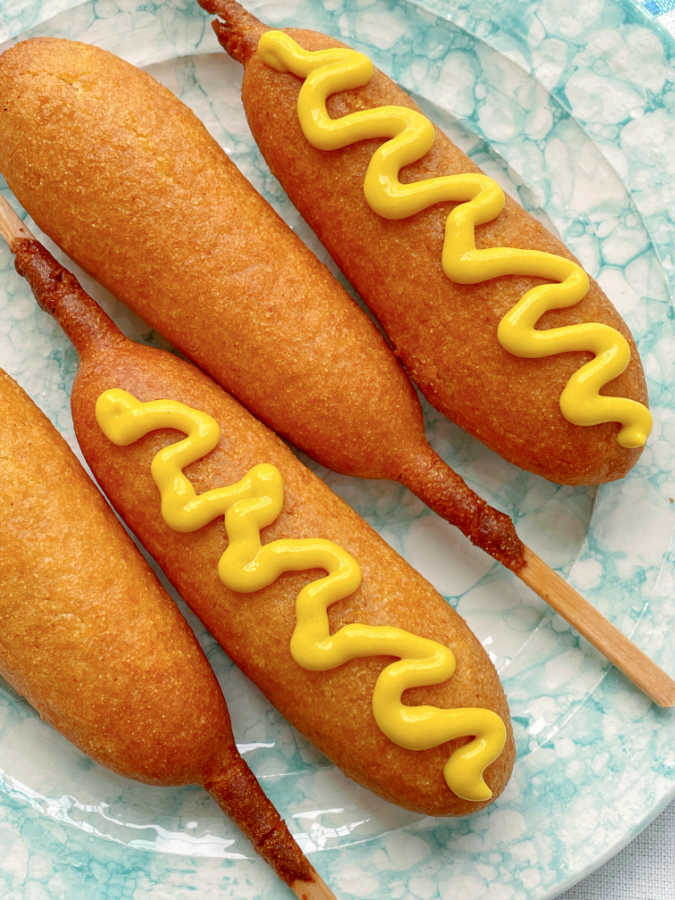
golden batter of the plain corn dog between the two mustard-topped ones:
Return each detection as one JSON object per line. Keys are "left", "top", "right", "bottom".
{"left": 0, "top": 39, "right": 522, "bottom": 569}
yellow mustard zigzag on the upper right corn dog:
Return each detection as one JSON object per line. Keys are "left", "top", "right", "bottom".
{"left": 258, "top": 31, "right": 651, "bottom": 447}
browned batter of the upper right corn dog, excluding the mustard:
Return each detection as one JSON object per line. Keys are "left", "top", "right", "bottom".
{"left": 207, "top": 0, "right": 646, "bottom": 484}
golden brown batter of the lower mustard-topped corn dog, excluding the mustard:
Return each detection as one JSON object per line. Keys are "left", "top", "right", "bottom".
{"left": 17, "top": 237, "right": 514, "bottom": 815}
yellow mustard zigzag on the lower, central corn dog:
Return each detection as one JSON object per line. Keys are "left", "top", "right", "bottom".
{"left": 96, "top": 389, "right": 506, "bottom": 802}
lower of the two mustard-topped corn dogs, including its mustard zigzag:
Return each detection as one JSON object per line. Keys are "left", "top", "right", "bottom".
{"left": 7, "top": 223, "right": 514, "bottom": 815}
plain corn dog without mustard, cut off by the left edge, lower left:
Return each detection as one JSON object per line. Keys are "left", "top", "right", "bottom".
{"left": 0, "top": 364, "right": 333, "bottom": 898}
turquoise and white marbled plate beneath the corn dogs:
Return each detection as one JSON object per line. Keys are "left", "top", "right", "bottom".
{"left": 0, "top": 0, "right": 675, "bottom": 900}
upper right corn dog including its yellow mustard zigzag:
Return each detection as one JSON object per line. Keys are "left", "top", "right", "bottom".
{"left": 205, "top": 0, "right": 651, "bottom": 484}
